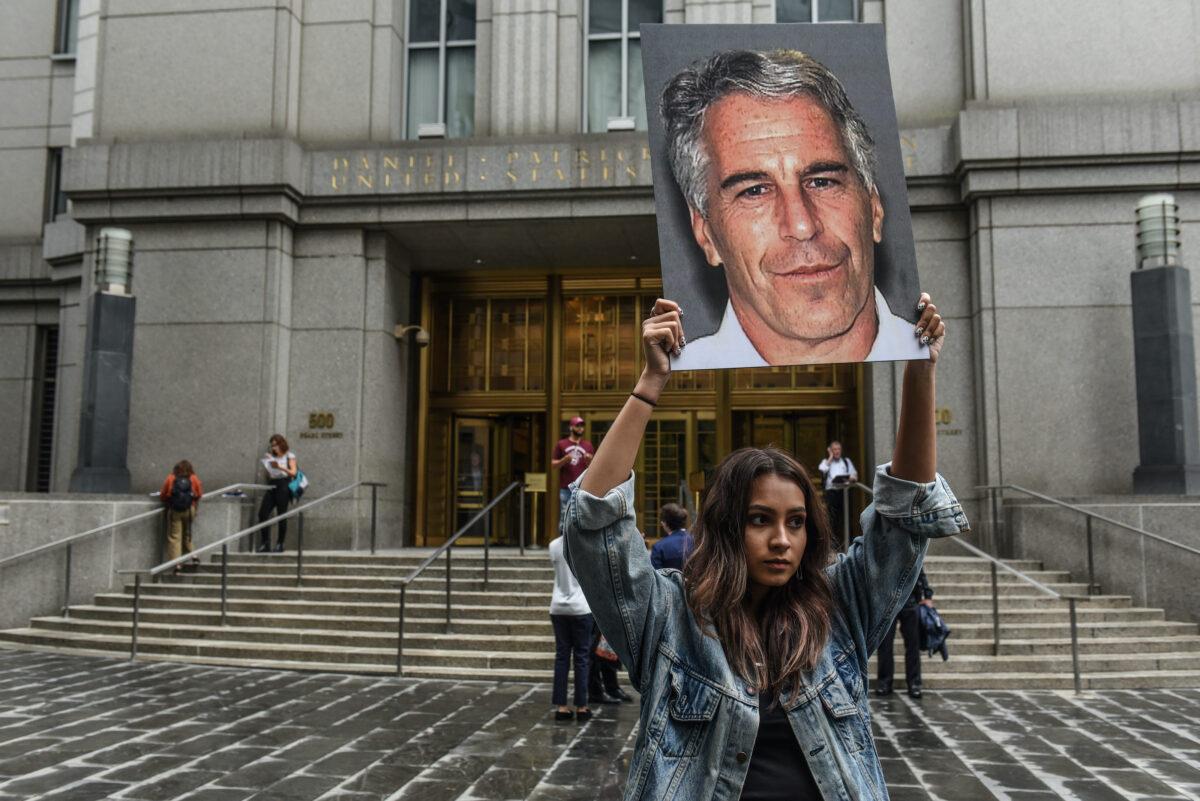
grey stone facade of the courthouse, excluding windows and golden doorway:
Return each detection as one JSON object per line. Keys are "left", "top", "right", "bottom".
{"left": 0, "top": 0, "right": 1200, "bottom": 537}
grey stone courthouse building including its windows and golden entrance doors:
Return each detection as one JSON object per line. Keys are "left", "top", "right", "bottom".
{"left": 0, "top": 0, "right": 1200, "bottom": 544}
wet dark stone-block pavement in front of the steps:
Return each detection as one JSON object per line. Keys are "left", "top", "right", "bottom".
{"left": 0, "top": 650, "right": 1200, "bottom": 801}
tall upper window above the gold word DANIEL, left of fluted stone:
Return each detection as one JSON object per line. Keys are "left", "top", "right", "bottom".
{"left": 406, "top": 0, "right": 475, "bottom": 139}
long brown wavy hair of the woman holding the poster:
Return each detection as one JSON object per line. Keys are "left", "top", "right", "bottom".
{"left": 683, "top": 447, "right": 834, "bottom": 693}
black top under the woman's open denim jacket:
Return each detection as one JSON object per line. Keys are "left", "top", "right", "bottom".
{"left": 742, "top": 692, "right": 821, "bottom": 801}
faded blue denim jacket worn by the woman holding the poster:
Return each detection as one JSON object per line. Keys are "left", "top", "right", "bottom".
{"left": 562, "top": 465, "right": 967, "bottom": 801}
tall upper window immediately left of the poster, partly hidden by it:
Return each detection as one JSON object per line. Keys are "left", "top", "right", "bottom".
{"left": 583, "top": 0, "right": 662, "bottom": 133}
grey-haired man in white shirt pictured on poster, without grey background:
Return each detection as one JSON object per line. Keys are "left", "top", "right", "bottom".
{"left": 661, "top": 50, "right": 929, "bottom": 369}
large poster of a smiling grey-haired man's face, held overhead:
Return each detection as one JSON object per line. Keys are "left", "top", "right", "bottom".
{"left": 642, "top": 24, "right": 928, "bottom": 369}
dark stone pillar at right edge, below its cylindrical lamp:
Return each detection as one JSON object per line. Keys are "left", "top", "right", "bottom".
{"left": 1130, "top": 266, "right": 1200, "bottom": 495}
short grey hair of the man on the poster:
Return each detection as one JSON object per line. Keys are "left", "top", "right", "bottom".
{"left": 659, "top": 50, "right": 875, "bottom": 217}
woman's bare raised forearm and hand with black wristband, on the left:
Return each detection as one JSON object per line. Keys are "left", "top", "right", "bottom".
{"left": 580, "top": 299, "right": 684, "bottom": 495}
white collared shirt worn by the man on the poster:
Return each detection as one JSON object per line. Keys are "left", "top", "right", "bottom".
{"left": 671, "top": 287, "right": 929, "bottom": 369}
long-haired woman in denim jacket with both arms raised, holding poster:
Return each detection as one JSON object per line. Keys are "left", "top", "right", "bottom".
{"left": 563, "top": 295, "right": 967, "bottom": 801}
